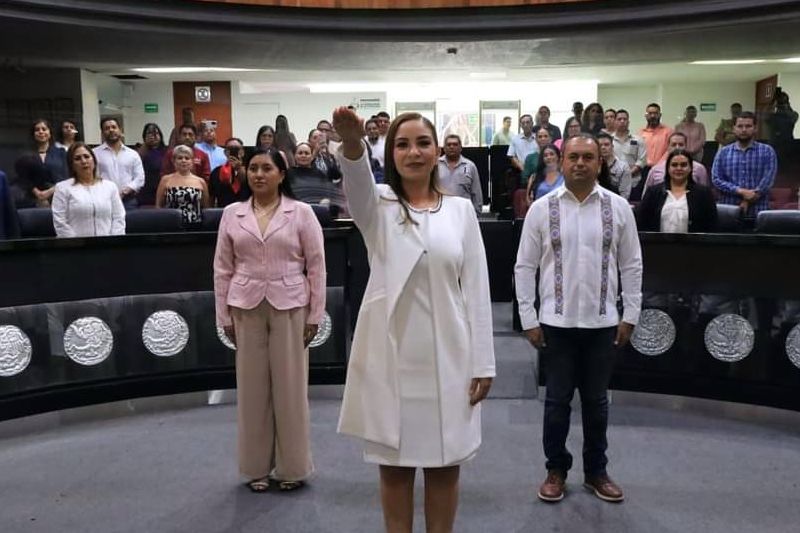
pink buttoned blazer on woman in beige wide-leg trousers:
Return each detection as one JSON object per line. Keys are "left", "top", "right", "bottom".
{"left": 214, "top": 196, "right": 325, "bottom": 326}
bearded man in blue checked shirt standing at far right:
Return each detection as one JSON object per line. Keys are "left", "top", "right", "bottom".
{"left": 711, "top": 111, "right": 778, "bottom": 217}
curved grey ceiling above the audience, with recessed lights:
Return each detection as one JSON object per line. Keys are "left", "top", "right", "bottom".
{"left": 0, "top": 0, "right": 800, "bottom": 84}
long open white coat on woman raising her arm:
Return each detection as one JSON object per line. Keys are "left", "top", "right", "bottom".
{"left": 332, "top": 144, "right": 495, "bottom": 464}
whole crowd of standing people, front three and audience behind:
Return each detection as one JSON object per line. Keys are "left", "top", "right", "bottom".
{"left": 0, "top": 93, "right": 788, "bottom": 532}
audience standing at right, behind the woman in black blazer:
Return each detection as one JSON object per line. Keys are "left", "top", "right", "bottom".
{"left": 504, "top": 99, "right": 784, "bottom": 227}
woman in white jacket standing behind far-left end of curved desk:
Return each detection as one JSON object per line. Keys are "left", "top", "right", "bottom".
{"left": 52, "top": 142, "right": 125, "bottom": 237}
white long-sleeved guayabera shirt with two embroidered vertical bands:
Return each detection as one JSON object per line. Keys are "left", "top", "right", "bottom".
{"left": 514, "top": 185, "right": 642, "bottom": 330}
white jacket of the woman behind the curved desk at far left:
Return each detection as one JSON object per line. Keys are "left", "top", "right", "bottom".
{"left": 52, "top": 178, "right": 125, "bottom": 237}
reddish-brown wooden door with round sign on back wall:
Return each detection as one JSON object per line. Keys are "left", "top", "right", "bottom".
{"left": 172, "top": 81, "right": 233, "bottom": 146}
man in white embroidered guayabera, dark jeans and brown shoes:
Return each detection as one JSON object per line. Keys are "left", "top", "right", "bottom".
{"left": 514, "top": 133, "right": 642, "bottom": 502}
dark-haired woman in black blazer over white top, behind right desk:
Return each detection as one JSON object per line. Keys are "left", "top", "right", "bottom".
{"left": 636, "top": 150, "right": 717, "bottom": 233}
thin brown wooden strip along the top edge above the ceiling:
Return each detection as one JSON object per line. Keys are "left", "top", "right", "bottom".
{"left": 199, "top": 0, "right": 593, "bottom": 9}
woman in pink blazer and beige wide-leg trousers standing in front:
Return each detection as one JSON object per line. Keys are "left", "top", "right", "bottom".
{"left": 214, "top": 148, "right": 325, "bottom": 492}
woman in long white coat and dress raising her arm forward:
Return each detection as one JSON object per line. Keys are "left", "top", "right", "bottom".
{"left": 333, "top": 107, "right": 495, "bottom": 532}
